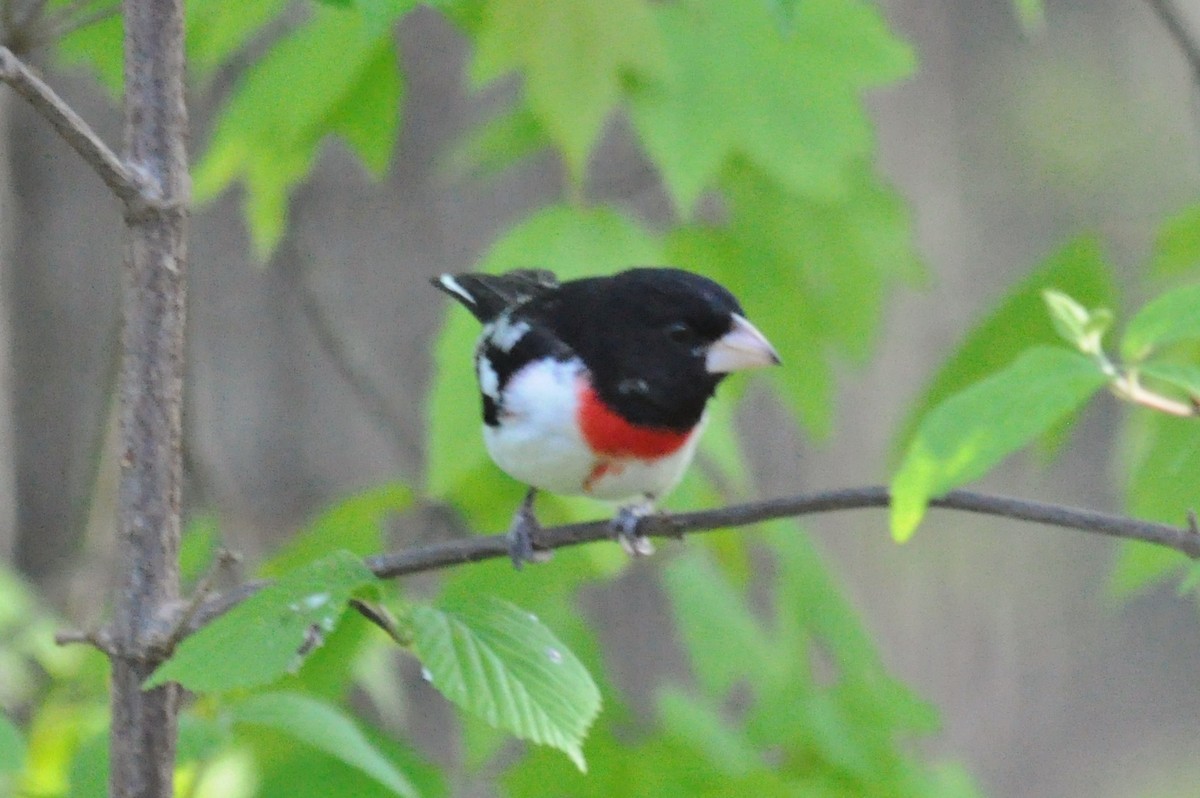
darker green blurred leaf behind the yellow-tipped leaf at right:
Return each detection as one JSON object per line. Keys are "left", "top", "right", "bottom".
{"left": 895, "top": 236, "right": 1116, "bottom": 449}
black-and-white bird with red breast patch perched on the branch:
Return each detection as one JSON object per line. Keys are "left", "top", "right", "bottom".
{"left": 433, "top": 269, "right": 779, "bottom": 566}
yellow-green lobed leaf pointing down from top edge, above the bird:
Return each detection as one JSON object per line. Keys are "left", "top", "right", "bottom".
{"left": 472, "top": 0, "right": 661, "bottom": 181}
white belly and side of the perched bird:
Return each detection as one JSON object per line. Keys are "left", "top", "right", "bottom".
{"left": 484, "top": 361, "right": 703, "bottom": 502}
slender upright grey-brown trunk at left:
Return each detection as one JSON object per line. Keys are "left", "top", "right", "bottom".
{"left": 109, "top": 0, "right": 188, "bottom": 798}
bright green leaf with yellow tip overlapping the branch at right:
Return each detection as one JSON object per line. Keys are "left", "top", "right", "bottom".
{"left": 892, "top": 347, "right": 1108, "bottom": 541}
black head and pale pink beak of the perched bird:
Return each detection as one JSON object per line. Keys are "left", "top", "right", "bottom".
{"left": 521, "top": 269, "right": 778, "bottom": 430}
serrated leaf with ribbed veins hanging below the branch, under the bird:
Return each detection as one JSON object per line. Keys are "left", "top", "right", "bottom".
{"left": 413, "top": 598, "right": 600, "bottom": 770}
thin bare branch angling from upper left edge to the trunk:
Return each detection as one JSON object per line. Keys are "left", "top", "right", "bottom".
{"left": 0, "top": 46, "right": 144, "bottom": 205}
